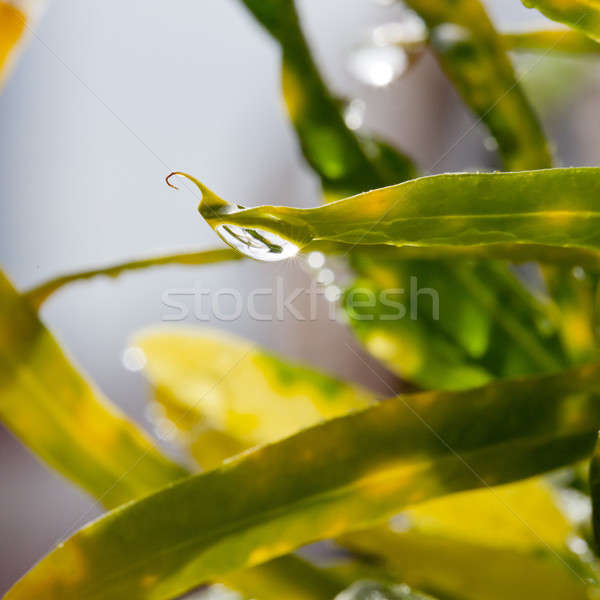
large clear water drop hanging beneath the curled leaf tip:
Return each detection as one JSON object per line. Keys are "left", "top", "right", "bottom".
{"left": 216, "top": 225, "right": 300, "bottom": 262}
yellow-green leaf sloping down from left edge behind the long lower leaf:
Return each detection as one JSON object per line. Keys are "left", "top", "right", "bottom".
{"left": 0, "top": 273, "right": 186, "bottom": 507}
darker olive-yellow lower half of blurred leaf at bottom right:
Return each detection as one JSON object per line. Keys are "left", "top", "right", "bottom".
{"left": 343, "top": 528, "right": 593, "bottom": 600}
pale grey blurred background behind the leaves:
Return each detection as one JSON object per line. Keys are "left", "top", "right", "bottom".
{"left": 0, "top": 0, "right": 600, "bottom": 593}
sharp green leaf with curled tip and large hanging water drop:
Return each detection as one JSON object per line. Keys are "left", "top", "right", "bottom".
{"left": 177, "top": 167, "right": 600, "bottom": 260}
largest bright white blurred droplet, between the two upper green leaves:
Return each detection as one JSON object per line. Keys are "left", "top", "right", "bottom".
{"left": 348, "top": 46, "right": 408, "bottom": 87}
